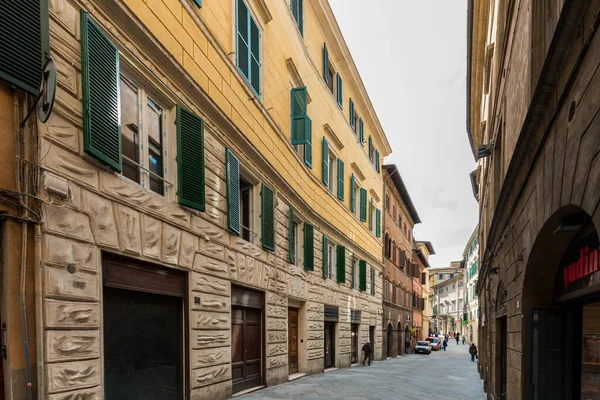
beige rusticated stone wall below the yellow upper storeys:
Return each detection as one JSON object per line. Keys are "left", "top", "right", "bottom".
{"left": 39, "top": 0, "right": 382, "bottom": 400}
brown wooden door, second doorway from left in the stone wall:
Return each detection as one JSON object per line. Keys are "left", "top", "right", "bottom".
{"left": 231, "top": 306, "right": 263, "bottom": 393}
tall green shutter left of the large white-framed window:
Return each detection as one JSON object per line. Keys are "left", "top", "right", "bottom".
{"left": 81, "top": 10, "right": 122, "bottom": 172}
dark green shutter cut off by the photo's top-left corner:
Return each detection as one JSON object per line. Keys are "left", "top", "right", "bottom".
{"left": 0, "top": 0, "right": 49, "bottom": 95}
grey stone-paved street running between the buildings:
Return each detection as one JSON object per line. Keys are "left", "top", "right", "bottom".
{"left": 238, "top": 340, "right": 486, "bottom": 400}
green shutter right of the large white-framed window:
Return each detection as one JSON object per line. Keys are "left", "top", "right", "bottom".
{"left": 177, "top": 105, "right": 205, "bottom": 211}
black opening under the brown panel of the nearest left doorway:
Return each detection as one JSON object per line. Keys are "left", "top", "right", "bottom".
{"left": 103, "top": 287, "right": 184, "bottom": 400}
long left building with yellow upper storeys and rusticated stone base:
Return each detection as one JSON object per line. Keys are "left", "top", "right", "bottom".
{"left": 0, "top": 0, "right": 391, "bottom": 400}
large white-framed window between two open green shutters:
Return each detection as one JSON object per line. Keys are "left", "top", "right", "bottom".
{"left": 120, "top": 75, "right": 169, "bottom": 196}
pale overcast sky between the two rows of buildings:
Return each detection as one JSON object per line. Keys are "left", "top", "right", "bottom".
{"left": 329, "top": 0, "right": 477, "bottom": 267}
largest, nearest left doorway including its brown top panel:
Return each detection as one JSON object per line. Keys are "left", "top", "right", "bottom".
{"left": 103, "top": 259, "right": 186, "bottom": 400}
